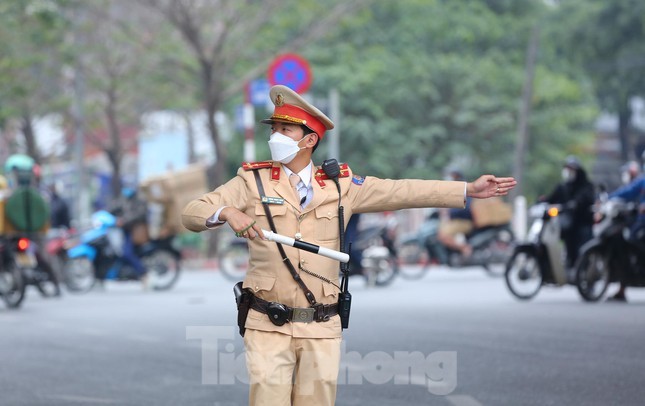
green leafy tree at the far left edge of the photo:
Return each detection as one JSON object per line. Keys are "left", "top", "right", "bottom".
{"left": 0, "top": 0, "right": 68, "bottom": 163}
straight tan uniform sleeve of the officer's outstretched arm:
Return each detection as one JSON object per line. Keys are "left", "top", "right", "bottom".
{"left": 347, "top": 175, "right": 466, "bottom": 213}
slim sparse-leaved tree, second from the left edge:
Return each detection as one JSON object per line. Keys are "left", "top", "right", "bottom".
{"left": 64, "top": 0, "right": 165, "bottom": 196}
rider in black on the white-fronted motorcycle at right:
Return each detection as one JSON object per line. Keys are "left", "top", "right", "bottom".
{"left": 542, "top": 156, "right": 596, "bottom": 268}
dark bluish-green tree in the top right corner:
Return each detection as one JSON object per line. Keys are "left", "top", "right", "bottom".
{"left": 558, "top": 0, "right": 645, "bottom": 161}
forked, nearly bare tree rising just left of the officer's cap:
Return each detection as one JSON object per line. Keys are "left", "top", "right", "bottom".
{"left": 139, "top": 0, "right": 364, "bottom": 186}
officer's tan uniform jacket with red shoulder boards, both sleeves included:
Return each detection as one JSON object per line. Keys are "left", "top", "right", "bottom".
{"left": 182, "top": 162, "right": 465, "bottom": 338}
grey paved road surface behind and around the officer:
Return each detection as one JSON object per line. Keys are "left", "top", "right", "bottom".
{"left": 0, "top": 269, "right": 645, "bottom": 406}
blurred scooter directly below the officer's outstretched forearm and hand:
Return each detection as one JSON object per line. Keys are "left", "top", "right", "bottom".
{"left": 399, "top": 211, "right": 515, "bottom": 279}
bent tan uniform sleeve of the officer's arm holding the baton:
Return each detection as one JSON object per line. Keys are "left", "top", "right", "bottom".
{"left": 181, "top": 169, "right": 248, "bottom": 231}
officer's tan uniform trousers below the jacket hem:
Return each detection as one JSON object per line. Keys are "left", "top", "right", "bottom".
{"left": 244, "top": 329, "right": 341, "bottom": 406}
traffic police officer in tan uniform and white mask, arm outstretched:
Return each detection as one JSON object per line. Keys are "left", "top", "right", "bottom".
{"left": 182, "top": 86, "right": 516, "bottom": 406}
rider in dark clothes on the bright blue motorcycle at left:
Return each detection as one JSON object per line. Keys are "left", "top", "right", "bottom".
{"left": 110, "top": 187, "right": 148, "bottom": 280}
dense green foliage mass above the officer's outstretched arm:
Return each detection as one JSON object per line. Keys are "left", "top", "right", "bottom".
{"left": 311, "top": 1, "right": 596, "bottom": 201}
